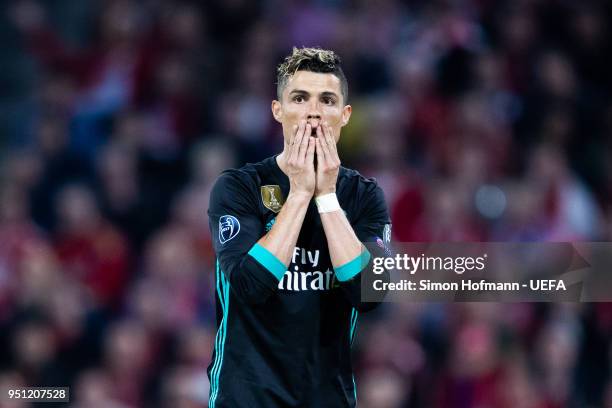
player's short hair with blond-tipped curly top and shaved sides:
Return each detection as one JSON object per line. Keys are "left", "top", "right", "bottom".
{"left": 276, "top": 47, "right": 348, "bottom": 103}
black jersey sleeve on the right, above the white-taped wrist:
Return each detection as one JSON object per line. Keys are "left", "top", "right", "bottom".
{"left": 340, "top": 182, "right": 391, "bottom": 312}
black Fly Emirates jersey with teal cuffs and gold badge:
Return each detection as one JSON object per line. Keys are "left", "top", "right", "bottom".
{"left": 203, "top": 157, "right": 390, "bottom": 408}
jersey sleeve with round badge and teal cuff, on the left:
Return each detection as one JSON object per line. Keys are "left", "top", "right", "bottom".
{"left": 208, "top": 171, "right": 286, "bottom": 304}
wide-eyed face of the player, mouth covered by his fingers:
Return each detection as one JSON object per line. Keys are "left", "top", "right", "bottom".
{"left": 272, "top": 71, "right": 351, "bottom": 142}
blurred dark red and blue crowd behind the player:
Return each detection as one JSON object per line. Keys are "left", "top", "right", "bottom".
{"left": 0, "top": 0, "right": 612, "bottom": 408}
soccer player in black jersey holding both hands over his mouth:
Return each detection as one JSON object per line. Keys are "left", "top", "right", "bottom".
{"left": 208, "top": 48, "right": 390, "bottom": 408}
